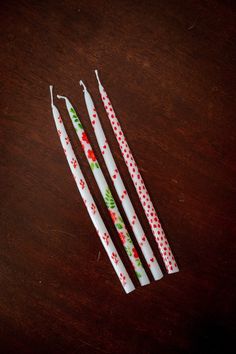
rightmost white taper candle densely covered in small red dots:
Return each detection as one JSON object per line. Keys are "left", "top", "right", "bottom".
{"left": 95, "top": 70, "right": 179, "bottom": 273}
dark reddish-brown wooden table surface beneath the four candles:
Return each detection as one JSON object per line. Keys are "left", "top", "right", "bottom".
{"left": 0, "top": 0, "right": 236, "bottom": 354}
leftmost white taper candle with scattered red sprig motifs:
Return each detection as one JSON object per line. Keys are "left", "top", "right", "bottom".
{"left": 50, "top": 86, "right": 135, "bottom": 293}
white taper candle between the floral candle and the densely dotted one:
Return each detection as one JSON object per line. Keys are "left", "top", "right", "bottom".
{"left": 78, "top": 82, "right": 163, "bottom": 280}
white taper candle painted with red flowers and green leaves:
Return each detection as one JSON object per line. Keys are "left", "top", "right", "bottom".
{"left": 57, "top": 95, "right": 150, "bottom": 285}
